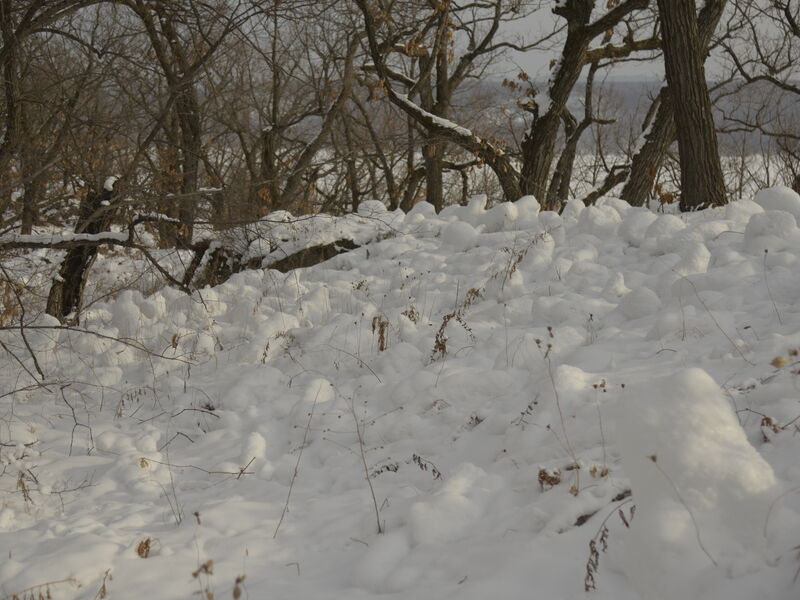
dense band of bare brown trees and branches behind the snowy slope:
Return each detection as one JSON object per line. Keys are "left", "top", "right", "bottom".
{"left": 0, "top": 0, "right": 800, "bottom": 318}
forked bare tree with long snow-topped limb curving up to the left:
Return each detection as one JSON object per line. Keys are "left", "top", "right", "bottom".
{"left": 356, "top": 0, "right": 659, "bottom": 208}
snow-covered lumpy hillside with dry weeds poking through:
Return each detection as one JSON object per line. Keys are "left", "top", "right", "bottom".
{"left": 0, "top": 188, "right": 800, "bottom": 600}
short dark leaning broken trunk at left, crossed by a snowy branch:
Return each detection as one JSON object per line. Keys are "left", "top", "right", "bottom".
{"left": 46, "top": 183, "right": 114, "bottom": 322}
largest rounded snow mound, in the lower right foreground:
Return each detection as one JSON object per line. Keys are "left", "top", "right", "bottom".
{"left": 617, "top": 368, "right": 780, "bottom": 600}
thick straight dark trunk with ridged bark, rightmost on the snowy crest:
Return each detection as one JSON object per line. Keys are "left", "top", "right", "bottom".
{"left": 658, "top": 0, "right": 727, "bottom": 211}
